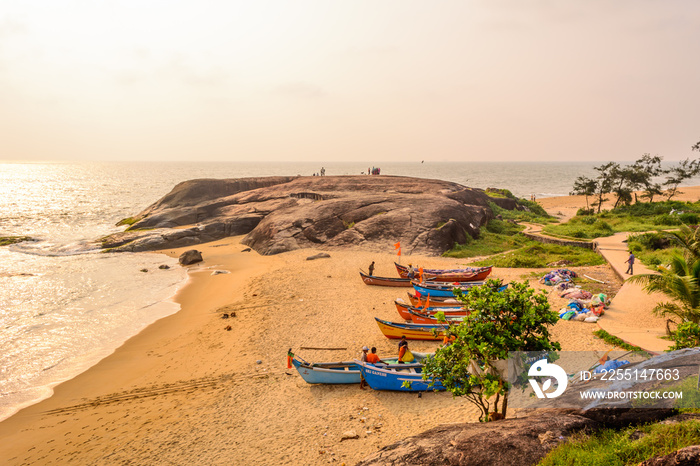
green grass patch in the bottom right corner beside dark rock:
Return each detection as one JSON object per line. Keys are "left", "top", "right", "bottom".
{"left": 539, "top": 420, "right": 700, "bottom": 466}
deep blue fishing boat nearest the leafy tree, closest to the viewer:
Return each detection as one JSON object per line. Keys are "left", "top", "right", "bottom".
{"left": 355, "top": 361, "right": 445, "bottom": 392}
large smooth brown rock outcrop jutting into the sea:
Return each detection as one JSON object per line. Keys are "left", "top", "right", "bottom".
{"left": 102, "top": 176, "right": 493, "bottom": 254}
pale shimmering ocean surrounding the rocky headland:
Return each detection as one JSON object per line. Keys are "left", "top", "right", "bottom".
{"left": 0, "top": 162, "right": 698, "bottom": 420}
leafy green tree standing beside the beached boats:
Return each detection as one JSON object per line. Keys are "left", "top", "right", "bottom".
{"left": 423, "top": 279, "right": 561, "bottom": 422}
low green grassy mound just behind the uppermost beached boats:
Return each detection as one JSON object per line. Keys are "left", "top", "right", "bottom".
{"left": 468, "top": 240, "right": 605, "bottom": 268}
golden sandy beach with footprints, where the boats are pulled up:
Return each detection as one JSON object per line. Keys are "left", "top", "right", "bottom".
{"left": 5, "top": 187, "right": 700, "bottom": 465}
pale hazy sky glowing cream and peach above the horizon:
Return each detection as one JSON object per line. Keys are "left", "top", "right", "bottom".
{"left": 0, "top": 0, "right": 700, "bottom": 163}
